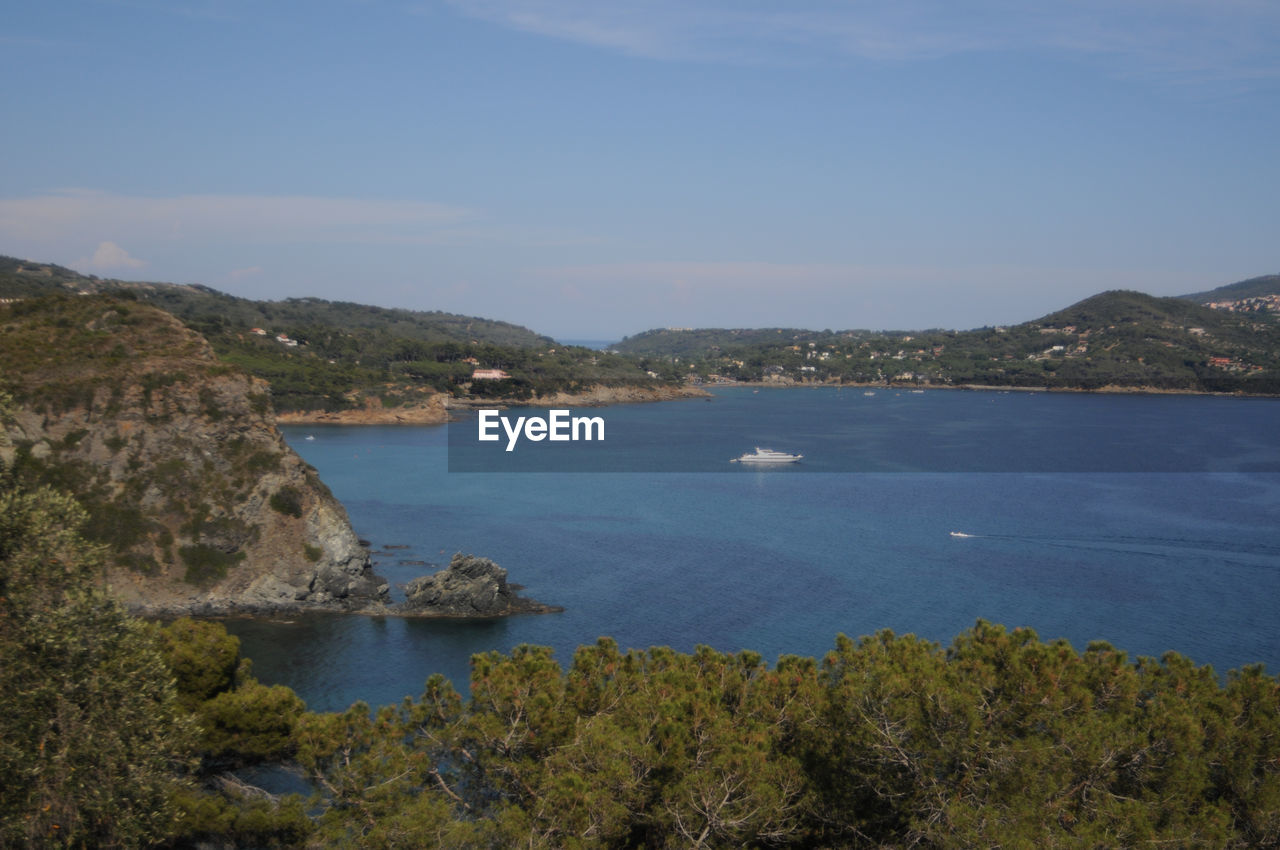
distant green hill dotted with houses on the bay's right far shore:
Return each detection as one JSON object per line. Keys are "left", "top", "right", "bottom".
{"left": 618, "top": 292, "right": 1280, "bottom": 394}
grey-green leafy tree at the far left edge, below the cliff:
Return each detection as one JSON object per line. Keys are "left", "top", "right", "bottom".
{"left": 0, "top": 458, "right": 192, "bottom": 847}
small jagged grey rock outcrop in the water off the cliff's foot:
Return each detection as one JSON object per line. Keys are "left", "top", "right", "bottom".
{"left": 401, "top": 553, "right": 563, "bottom": 617}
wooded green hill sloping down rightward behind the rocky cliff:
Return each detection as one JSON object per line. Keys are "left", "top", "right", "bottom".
{"left": 0, "top": 257, "right": 680, "bottom": 412}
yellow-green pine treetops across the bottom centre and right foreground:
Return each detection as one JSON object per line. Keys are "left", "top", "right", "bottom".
{"left": 288, "top": 621, "right": 1280, "bottom": 847}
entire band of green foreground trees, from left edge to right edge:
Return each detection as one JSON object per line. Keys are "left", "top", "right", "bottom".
{"left": 0, "top": 512, "right": 1280, "bottom": 849}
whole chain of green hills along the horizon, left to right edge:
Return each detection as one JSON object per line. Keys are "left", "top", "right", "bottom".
{"left": 10, "top": 259, "right": 1280, "bottom": 396}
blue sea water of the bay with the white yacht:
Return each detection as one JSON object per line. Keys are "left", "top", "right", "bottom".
{"left": 228, "top": 388, "right": 1280, "bottom": 710}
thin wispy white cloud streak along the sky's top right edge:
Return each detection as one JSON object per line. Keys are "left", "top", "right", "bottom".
{"left": 445, "top": 0, "right": 1280, "bottom": 79}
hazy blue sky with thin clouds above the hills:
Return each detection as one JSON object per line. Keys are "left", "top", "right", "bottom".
{"left": 0, "top": 0, "right": 1280, "bottom": 339}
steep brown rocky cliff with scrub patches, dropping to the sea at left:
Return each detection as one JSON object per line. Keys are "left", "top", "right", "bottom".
{"left": 0, "top": 296, "right": 388, "bottom": 613}
